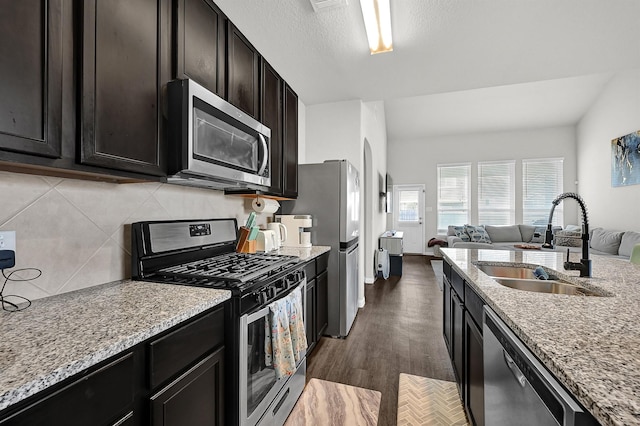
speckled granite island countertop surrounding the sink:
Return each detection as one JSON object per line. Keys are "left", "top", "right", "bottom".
{"left": 441, "top": 248, "right": 640, "bottom": 425}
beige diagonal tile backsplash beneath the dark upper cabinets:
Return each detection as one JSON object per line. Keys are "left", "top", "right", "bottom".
{"left": 0, "top": 171, "right": 252, "bottom": 299}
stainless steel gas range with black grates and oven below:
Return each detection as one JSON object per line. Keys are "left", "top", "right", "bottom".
{"left": 131, "top": 219, "right": 306, "bottom": 426}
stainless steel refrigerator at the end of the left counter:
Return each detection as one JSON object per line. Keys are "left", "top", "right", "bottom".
{"left": 281, "top": 160, "right": 360, "bottom": 337}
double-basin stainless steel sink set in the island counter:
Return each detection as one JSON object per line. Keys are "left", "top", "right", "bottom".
{"left": 476, "top": 265, "right": 602, "bottom": 296}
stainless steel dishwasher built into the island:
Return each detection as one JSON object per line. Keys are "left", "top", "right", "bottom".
{"left": 482, "top": 305, "right": 598, "bottom": 426}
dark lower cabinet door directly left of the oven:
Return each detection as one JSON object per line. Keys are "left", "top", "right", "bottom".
{"left": 151, "top": 348, "right": 224, "bottom": 426}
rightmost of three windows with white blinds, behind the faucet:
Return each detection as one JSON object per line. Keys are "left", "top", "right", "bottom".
{"left": 522, "top": 158, "right": 563, "bottom": 226}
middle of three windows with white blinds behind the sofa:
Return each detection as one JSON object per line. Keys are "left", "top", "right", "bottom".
{"left": 477, "top": 160, "right": 516, "bottom": 225}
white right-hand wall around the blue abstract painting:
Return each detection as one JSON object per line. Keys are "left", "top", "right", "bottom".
{"left": 577, "top": 70, "right": 640, "bottom": 231}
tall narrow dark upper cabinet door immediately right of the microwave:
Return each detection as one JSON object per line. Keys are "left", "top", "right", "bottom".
{"left": 260, "top": 58, "right": 283, "bottom": 195}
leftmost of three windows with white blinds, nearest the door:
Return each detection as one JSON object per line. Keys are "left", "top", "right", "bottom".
{"left": 437, "top": 164, "right": 471, "bottom": 233}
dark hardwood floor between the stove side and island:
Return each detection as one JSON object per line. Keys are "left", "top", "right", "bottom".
{"left": 307, "top": 255, "right": 454, "bottom": 426}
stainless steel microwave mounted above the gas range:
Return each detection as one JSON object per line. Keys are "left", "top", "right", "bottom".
{"left": 167, "top": 79, "right": 271, "bottom": 189}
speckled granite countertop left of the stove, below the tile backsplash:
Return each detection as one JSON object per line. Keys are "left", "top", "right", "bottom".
{"left": 0, "top": 281, "right": 231, "bottom": 410}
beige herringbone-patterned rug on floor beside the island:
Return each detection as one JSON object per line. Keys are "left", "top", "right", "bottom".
{"left": 398, "top": 373, "right": 469, "bottom": 426}
